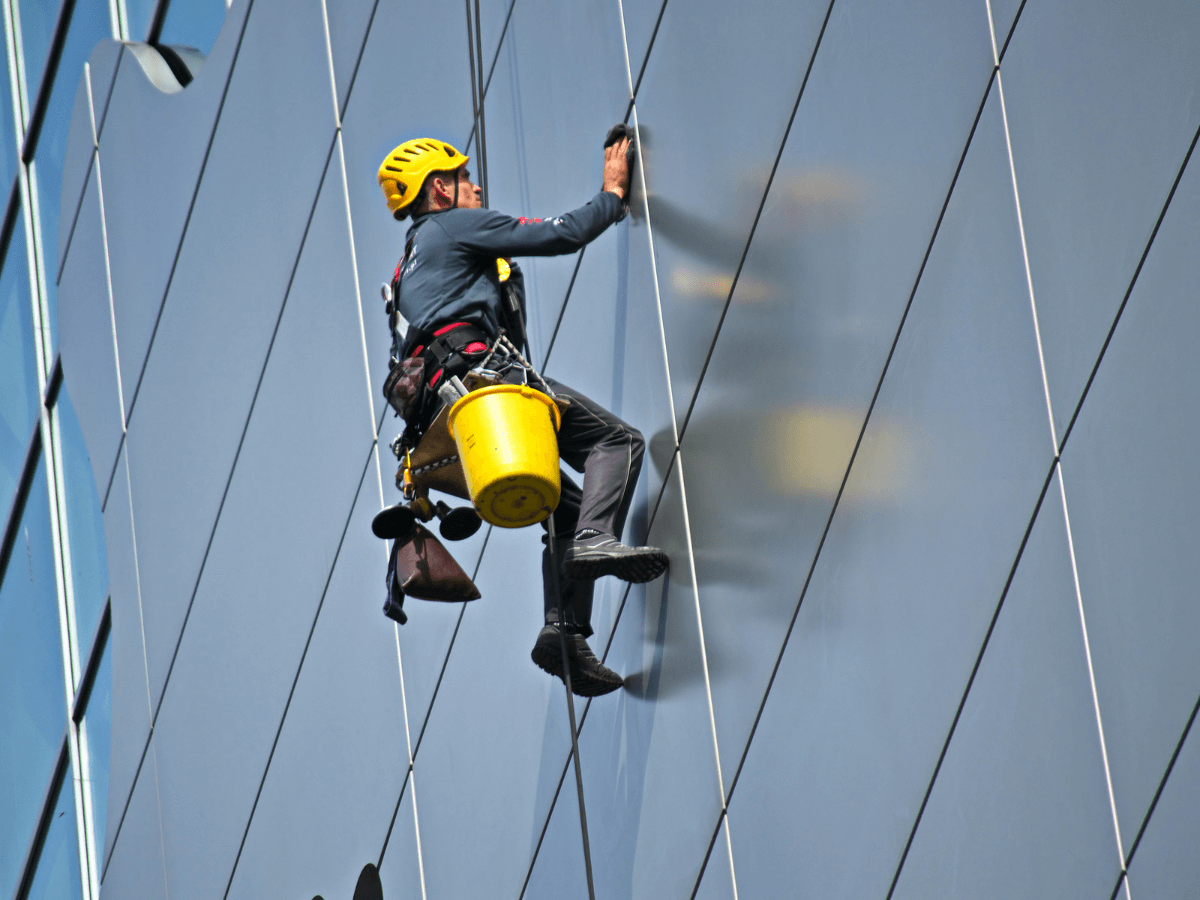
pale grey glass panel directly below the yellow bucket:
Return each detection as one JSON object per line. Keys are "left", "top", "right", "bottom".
{"left": 415, "top": 528, "right": 573, "bottom": 896}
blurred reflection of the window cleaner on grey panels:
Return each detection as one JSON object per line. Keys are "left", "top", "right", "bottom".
{"left": 638, "top": 158, "right": 911, "bottom": 592}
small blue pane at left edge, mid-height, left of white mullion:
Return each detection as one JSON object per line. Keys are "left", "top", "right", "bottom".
{"left": 0, "top": 215, "right": 37, "bottom": 510}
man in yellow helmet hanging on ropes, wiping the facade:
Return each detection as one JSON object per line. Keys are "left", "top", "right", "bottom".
{"left": 379, "top": 126, "right": 667, "bottom": 696}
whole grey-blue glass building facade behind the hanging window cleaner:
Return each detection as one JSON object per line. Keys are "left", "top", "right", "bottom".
{"left": 0, "top": 0, "right": 1200, "bottom": 900}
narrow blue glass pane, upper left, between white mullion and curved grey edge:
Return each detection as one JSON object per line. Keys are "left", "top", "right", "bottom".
{"left": 34, "top": 0, "right": 112, "bottom": 355}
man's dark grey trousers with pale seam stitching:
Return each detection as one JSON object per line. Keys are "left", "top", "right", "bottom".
{"left": 541, "top": 378, "right": 646, "bottom": 637}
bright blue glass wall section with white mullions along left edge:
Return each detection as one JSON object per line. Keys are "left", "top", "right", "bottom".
{"left": 0, "top": 0, "right": 228, "bottom": 900}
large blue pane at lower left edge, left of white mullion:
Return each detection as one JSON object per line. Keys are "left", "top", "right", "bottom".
{"left": 0, "top": 460, "right": 67, "bottom": 896}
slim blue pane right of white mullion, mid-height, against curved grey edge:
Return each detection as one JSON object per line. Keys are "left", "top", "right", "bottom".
{"left": 56, "top": 388, "right": 108, "bottom": 659}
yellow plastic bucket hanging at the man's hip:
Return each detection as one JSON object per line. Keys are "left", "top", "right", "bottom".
{"left": 449, "top": 384, "right": 560, "bottom": 528}
